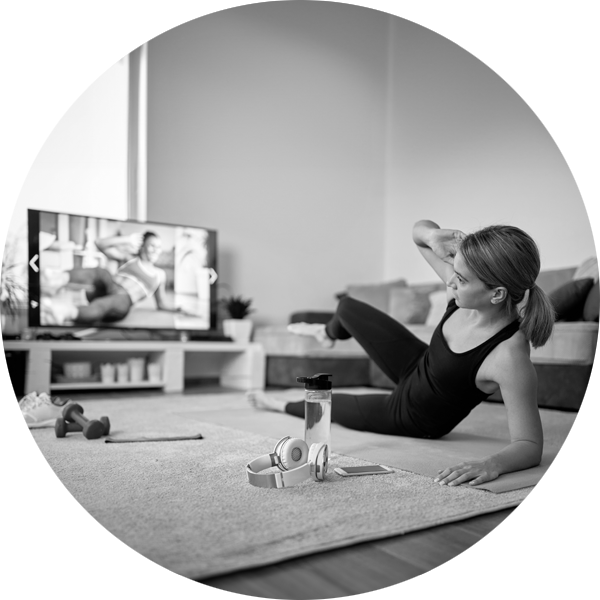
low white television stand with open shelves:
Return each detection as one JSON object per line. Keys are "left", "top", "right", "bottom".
{"left": 0, "top": 340, "right": 266, "bottom": 394}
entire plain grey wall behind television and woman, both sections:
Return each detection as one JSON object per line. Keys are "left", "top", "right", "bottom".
{"left": 148, "top": 0, "right": 600, "bottom": 323}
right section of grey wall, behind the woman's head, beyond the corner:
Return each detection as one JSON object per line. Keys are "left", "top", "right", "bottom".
{"left": 384, "top": 0, "right": 600, "bottom": 281}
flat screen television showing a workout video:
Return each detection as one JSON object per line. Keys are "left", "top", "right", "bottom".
{"left": 28, "top": 209, "right": 218, "bottom": 338}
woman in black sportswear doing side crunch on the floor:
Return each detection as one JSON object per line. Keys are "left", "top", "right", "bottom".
{"left": 248, "top": 220, "right": 554, "bottom": 485}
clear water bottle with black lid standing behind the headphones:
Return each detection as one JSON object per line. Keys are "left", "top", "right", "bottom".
{"left": 296, "top": 373, "right": 332, "bottom": 453}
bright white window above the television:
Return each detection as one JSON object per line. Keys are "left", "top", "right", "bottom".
{"left": 0, "top": 6, "right": 128, "bottom": 239}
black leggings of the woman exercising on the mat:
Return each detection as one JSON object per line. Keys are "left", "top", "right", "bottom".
{"left": 285, "top": 296, "right": 427, "bottom": 437}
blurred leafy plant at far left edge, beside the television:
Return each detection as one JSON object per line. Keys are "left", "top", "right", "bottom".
{"left": 0, "top": 231, "right": 26, "bottom": 334}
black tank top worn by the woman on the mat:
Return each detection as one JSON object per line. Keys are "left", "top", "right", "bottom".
{"left": 401, "top": 300, "right": 519, "bottom": 438}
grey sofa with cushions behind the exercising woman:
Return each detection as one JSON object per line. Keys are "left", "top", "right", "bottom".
{"left": 254, "top": 259, "right": 600, "bottom": 413}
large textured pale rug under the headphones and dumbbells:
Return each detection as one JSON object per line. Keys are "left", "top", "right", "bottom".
{"left": 0, "top": 393, "right": 600, "bottom": 580}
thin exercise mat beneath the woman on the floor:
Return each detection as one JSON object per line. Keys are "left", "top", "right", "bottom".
{"left": 188, "top": 390, "right": 600, "bottom": 493}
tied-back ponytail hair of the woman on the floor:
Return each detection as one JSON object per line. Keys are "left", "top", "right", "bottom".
{"left": 460, "top": 225, "right": 556, "bottom": 348}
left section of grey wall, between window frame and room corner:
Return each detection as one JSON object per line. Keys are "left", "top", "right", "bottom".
{"left": 148, "top": 0, "right": 389, "bottom": 323}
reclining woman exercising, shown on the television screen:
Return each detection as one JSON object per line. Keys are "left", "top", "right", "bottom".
{"left": 41, "top": 231, "right": 178, "bottom": 325}
